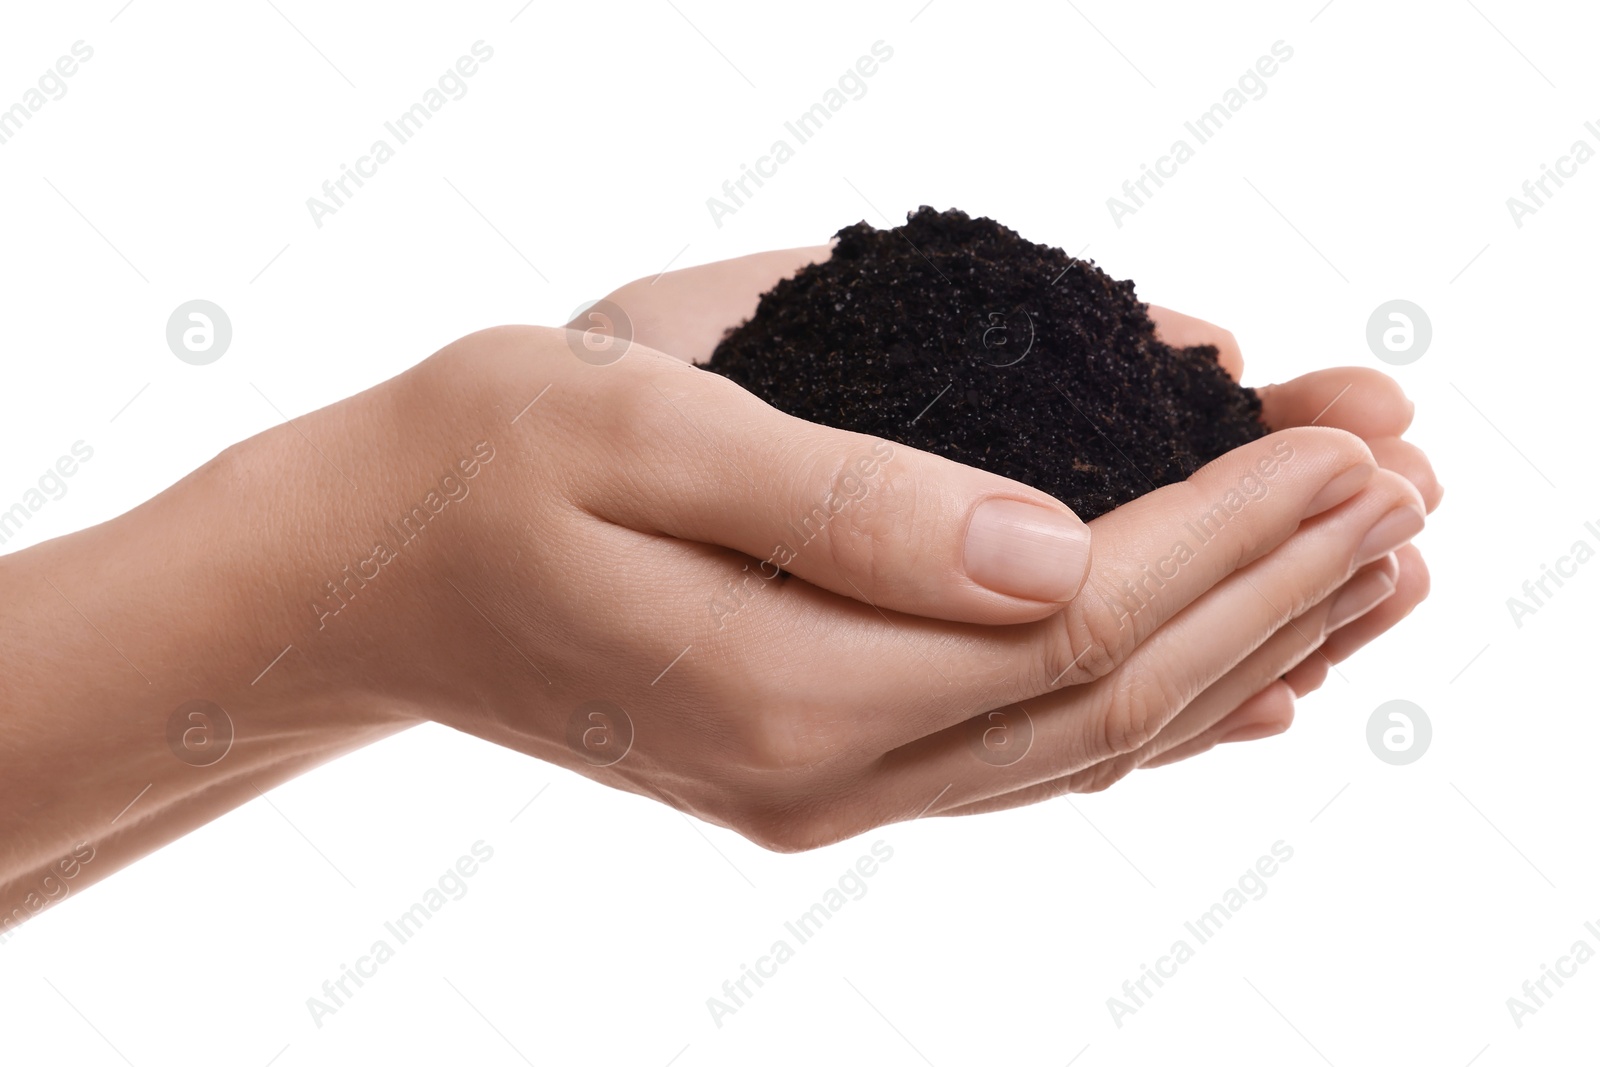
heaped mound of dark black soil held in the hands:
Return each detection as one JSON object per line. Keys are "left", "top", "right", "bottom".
{"left": 709, "top": 208, "right": 1267, "bottom": 520}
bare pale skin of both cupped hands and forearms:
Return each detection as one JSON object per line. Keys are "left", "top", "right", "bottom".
{"left": 0, "top": 246, "right": 1440, "bottom": 926}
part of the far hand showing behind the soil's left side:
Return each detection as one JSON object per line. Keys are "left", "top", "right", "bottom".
{"left": 585, "top": 245, "right": 832, "bottom": 363}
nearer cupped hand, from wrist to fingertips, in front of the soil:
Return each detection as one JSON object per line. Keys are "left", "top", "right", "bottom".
{"left": 387, "top": 328, "right": 1422, "bottom": 849}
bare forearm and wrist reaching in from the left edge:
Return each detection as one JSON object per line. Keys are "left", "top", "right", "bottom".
{"left": 0, "top": 375, "right": 444, "bottom": 929}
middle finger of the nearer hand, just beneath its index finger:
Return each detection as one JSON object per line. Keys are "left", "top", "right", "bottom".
{"left": 883, "top": 474, "right": 1422, "bottom": 806}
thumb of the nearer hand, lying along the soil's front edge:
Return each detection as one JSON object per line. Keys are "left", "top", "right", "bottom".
{"left": 586, "top": 346, "right": 1090, "bottom": 624}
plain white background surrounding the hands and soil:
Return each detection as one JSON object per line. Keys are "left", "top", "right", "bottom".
{"left": 0, "top": 0, "right": 1600, "bottom": 1067}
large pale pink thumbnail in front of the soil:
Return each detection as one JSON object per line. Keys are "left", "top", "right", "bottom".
{"left": 965, "top": 501, "right": 1090, "bottom": 603}
